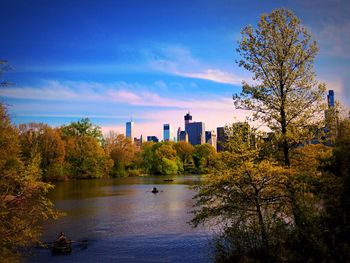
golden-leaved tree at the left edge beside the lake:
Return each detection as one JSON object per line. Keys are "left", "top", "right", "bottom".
{"left": 0, "top": 104, "right": 58, "bottom": 262}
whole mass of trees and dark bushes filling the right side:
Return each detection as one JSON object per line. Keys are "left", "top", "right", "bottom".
{"left": 191, "top": 9, "right": 350, "bottom": 262}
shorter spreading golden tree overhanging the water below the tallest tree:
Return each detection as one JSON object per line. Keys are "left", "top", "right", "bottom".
{"left": 191, "top": 125, "right": 291, "bottom": 262}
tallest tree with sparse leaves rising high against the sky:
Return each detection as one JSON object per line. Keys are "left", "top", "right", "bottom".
{"left": 234, "top": 9, "right": 325, "bottom": 166}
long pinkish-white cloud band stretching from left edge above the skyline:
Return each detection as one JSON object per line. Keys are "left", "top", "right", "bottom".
{"left": 0, "top": 81, "right": 235, "bottom": 109}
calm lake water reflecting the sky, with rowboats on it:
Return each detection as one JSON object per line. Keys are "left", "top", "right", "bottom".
{"left": 23, "top": 176, "right": 212, "bottom": 263}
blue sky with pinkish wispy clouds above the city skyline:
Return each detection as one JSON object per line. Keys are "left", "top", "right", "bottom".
{"left": 0, "top": 0, "right": 350, "bottom": 139}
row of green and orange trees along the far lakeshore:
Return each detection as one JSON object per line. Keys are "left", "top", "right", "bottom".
{"left": 18, "top": 118, "right": 217, "bottom": 181}
